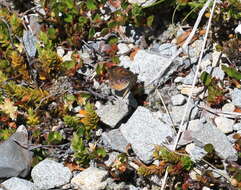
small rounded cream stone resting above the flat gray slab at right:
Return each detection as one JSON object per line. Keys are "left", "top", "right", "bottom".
{"left": 214, "top": 117, "right": 234, "bottom": 133}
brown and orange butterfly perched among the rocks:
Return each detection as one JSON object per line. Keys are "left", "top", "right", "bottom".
{"left": 108, "top": 66, "right": 137, "bottom": 93}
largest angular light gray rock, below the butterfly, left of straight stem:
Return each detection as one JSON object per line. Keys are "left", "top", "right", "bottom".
{"left": 120, "top": 106, "right": 173, "bottom": 163}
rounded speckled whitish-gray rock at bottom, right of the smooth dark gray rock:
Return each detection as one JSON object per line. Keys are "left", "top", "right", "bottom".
{"left": 31, "top": 159, "right": 72, "bottom": 190}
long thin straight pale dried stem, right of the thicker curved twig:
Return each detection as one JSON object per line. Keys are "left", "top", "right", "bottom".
{"left": 173, "top": 0, "right": 216, "bottom": 150}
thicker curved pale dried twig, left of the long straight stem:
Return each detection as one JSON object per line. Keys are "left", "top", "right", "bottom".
{"left": 148, "top": 0, "right": 211, "bottom": 85}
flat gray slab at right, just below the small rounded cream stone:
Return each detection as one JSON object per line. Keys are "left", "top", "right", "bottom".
{"left": 191, "top": 123, "right": 237, "bottom": 161}
